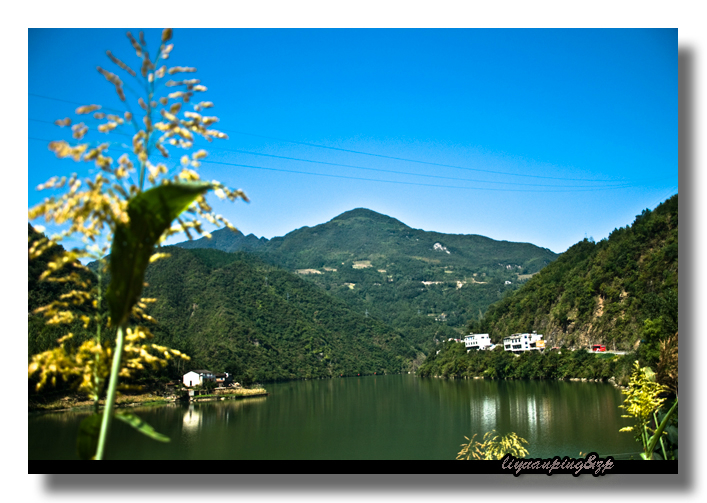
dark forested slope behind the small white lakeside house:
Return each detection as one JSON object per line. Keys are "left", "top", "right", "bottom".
{"left": 144, "top": 247, "right": 419, "bottom": 382}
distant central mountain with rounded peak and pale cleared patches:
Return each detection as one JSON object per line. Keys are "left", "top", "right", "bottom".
{"left": 178, "top": 208, "right": 557, "bottom": 350}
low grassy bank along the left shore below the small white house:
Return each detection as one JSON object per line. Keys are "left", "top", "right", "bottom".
{"left": 28, "top": 388, "right": 268, "bottom": 412}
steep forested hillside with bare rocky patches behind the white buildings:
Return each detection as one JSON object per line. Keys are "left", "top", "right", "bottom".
{"left": 469, "top": 194, "right": 678, "bottom": 361}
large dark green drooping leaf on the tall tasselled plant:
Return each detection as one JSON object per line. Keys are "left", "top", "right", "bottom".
{"left": 106, "top": 182, "right": 213, "bottom": 326}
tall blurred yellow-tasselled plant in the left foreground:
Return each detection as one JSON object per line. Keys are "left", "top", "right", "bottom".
{"left": 28, "top": 29, "right": 248, "bottom": 459}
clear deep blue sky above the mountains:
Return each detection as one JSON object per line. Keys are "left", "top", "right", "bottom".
{"left": 28, "top": 28, "right": 678, "bottom": 252}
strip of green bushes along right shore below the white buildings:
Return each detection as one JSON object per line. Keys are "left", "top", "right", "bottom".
{"left": 417, "top": 342, "right": 636, "bottom": 384}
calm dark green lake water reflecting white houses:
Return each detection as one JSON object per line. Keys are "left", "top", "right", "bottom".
{"left": 28, "top": 375, "right": 638, "bottom": 460}
